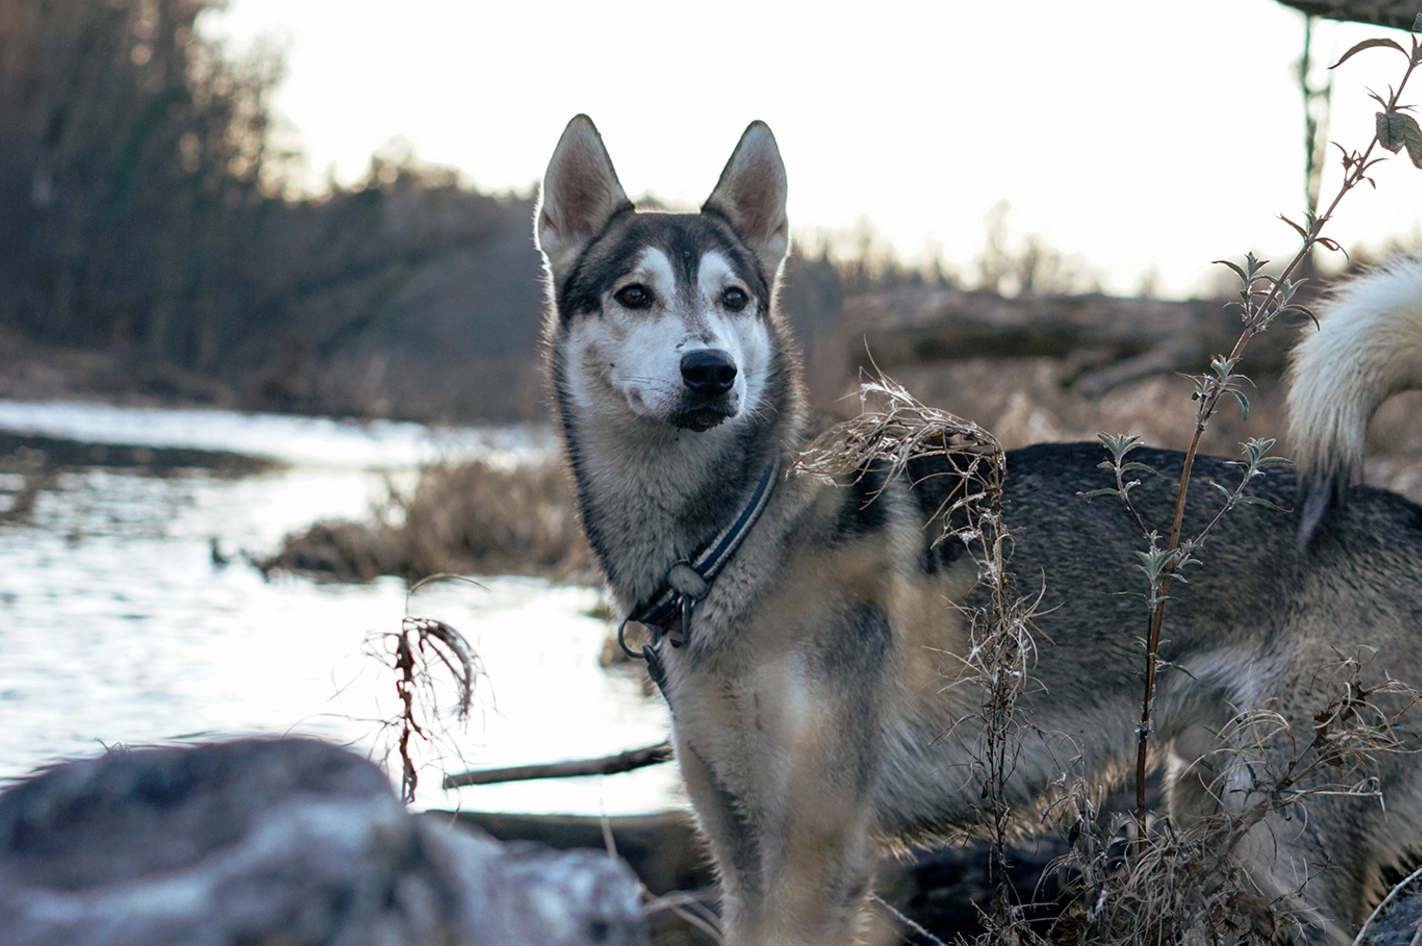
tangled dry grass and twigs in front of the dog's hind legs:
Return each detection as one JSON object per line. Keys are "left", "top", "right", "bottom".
{"left": 1023, "top": 647, "right": 1422, "bottom": 946}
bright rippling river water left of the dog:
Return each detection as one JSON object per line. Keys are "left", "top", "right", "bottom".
{"left": 0, "top": 401, "right": 685, "bottom": 814}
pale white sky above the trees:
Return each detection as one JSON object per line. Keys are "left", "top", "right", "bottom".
{"left": 206, "top": 0, "right": 1422, "bottom": 294}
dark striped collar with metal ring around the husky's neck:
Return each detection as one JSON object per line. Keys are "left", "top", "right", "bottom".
{"left": 617, "top": 457, "right": 781, "bottom": 689}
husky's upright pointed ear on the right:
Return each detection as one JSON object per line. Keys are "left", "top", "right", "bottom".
{"left": 701, "top": 121, "right": 791, "bottom": 279}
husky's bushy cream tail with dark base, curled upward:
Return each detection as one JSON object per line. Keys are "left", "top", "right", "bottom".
{"left": 1288, "top": 253, "right": 1422, "bottom": 548}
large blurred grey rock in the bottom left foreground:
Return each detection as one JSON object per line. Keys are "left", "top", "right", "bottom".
{"left": 0, "top": 738, "right": 646, "bottom": 946}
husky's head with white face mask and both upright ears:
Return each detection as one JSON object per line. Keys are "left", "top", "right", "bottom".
{"left": 535, "top": 115, "right": 789, "bottom": 432}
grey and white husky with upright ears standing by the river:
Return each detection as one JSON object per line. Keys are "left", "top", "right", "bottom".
{"left": 535, "top": 115, "right": 1422, "bottom": 946}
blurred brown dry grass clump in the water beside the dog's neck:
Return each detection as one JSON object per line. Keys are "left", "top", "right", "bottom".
{"left": 256, "top": 461, "right": 592, "bottom": 582}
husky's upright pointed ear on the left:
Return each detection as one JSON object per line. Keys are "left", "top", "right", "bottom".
{"left": 533, "top": 115, "right": 631, "bottom": 279}
